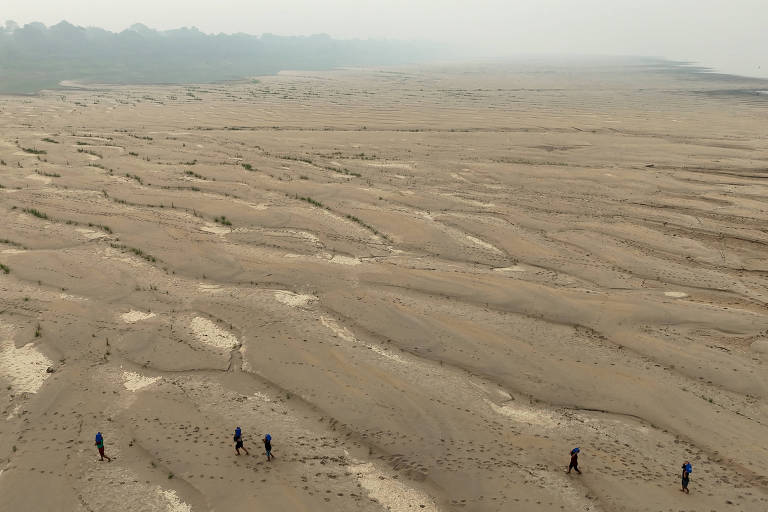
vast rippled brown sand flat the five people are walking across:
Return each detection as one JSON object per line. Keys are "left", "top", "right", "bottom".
{"left": 0, "top": 62, "right": 768, "bottom": 512}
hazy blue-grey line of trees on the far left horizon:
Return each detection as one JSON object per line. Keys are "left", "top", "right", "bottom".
{"left": 0, "top": 21, "right": 440, "bottom": 94}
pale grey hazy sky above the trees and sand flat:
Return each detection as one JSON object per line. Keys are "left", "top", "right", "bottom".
{"left": 6, "top": 0, "right": 768, "bottom": 77}
